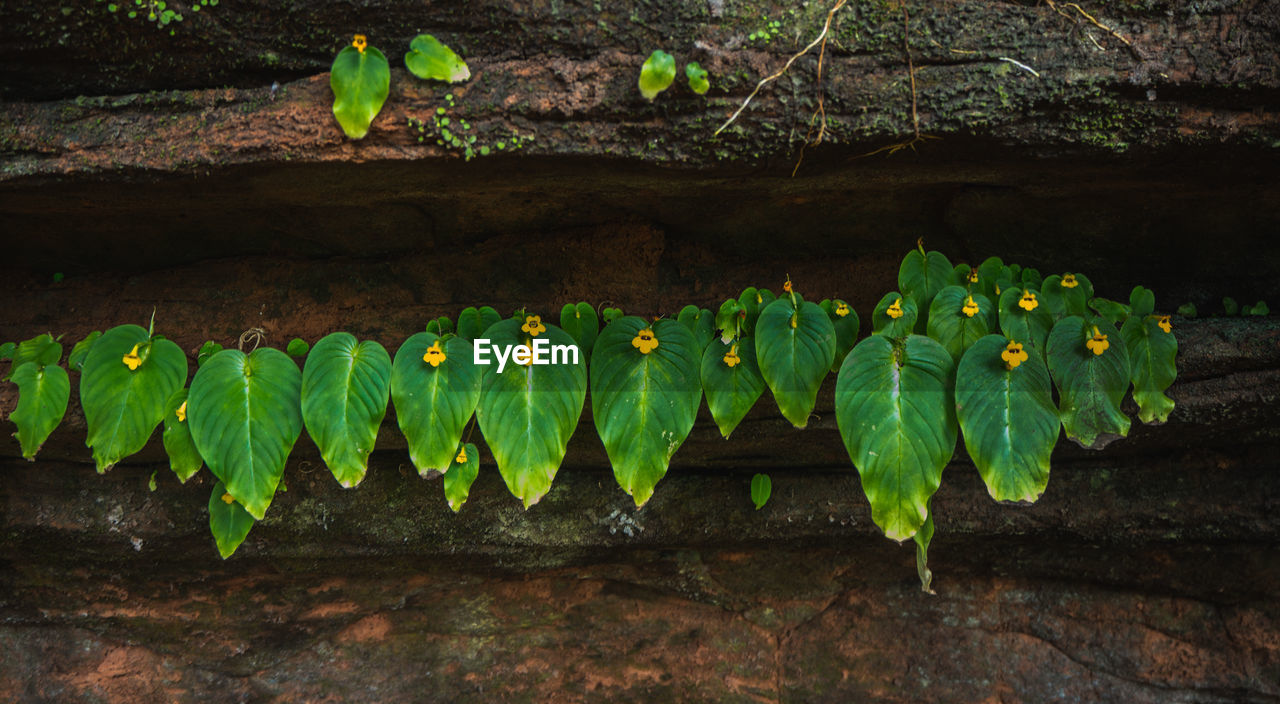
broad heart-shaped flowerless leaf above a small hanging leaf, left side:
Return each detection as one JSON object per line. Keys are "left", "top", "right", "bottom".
{"left": 188, "top": 342, "right": 302, "bottom": 521}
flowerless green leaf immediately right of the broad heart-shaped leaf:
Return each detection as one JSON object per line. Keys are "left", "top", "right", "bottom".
{"left": 302, "top": 333, "right": 392, "bottom": 489}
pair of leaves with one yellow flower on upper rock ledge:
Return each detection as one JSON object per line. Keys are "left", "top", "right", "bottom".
{"left": 329, "top": 35, "right": 471, "bottom": 140}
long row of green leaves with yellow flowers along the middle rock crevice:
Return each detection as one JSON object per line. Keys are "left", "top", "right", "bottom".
{"left": 9, "top": 247, "right": 1178, "bottom": 579}
